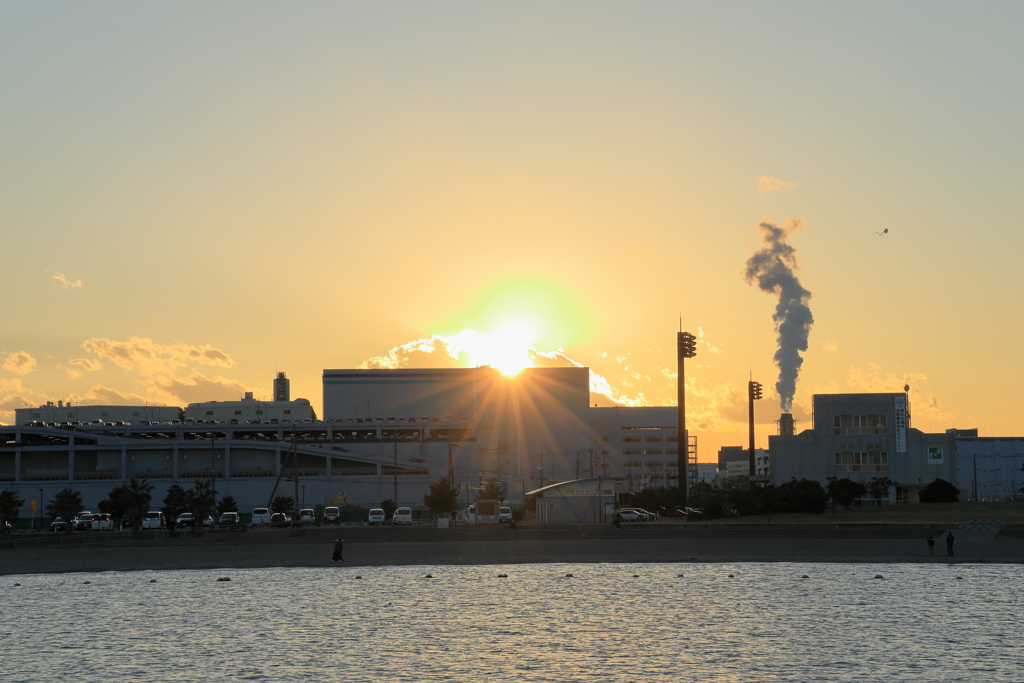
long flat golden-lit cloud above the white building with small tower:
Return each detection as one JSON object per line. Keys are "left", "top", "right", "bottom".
{"left": 82, "top": 337, "right": 236, "bottom": 376}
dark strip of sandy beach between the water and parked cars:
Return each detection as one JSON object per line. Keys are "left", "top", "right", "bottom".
{"left": 0, "top": 524, "right": 1024, "bottom": 574}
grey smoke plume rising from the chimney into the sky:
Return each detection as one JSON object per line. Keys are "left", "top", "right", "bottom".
{"left": 745, "top": 218, "right": 814, "bottom": 413}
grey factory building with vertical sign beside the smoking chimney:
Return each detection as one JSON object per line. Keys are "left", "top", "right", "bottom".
{"left": 768, "top": 393, "right": 956, "bottom": 503}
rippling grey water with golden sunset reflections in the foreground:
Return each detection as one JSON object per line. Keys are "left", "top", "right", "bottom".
{"left": 0, "top": 563, "right": 1024, "bottom": 683}
